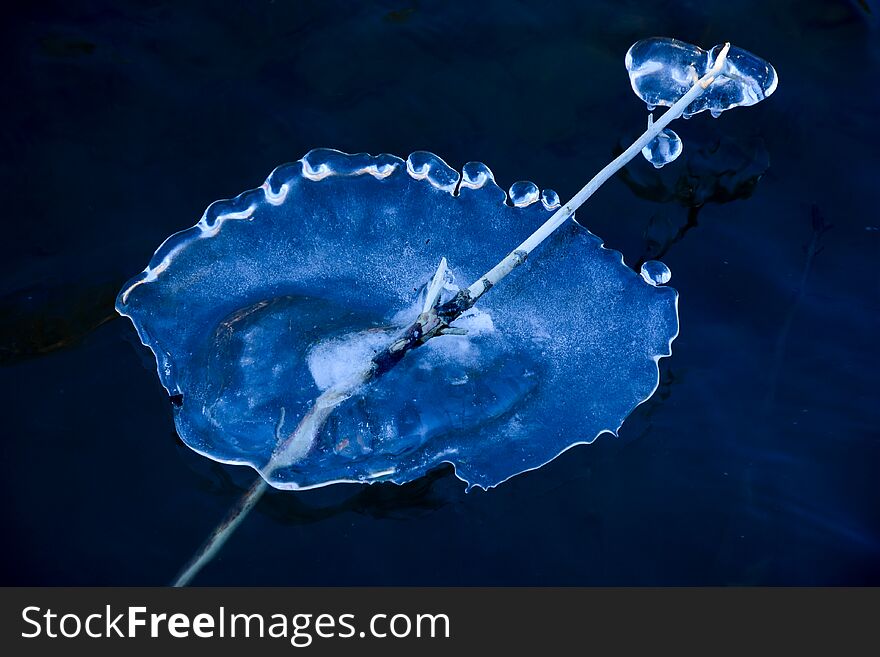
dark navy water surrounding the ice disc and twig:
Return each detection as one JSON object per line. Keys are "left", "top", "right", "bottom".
{"left": 0, "top": 0, "right": 880, "bottom": 585}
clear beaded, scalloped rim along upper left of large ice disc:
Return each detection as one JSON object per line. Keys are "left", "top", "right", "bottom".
{"left": 116, "top": 148, "right": 574, "bottom": 312}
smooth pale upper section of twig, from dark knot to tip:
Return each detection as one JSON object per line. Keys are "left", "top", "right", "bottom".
{"left": 460, "top": 43, "right": 730, "bottom": 306}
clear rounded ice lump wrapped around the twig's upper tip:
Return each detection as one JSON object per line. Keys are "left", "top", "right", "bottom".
{"left": 626, "top": 37, "right": 777, "bottom": 117}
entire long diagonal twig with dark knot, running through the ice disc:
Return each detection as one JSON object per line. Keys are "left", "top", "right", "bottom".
{"left": 173, "top": 43, "right": 730, "bottom": 586}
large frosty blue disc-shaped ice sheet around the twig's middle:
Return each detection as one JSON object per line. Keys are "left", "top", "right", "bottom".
{"left": 117, "top": 150, "right": 678, "bottom": 488}
